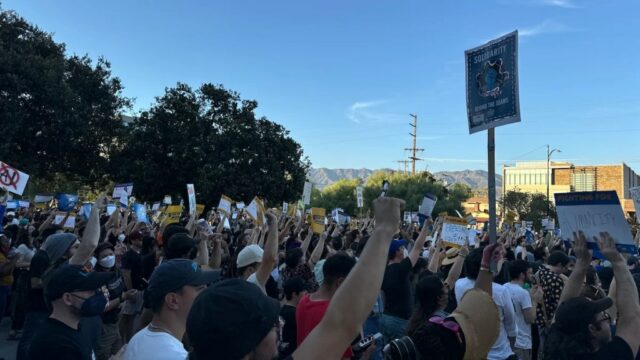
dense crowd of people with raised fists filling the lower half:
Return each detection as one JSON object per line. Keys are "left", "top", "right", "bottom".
{"left": 0, "top": 196, "right": 640, "bottom": 360}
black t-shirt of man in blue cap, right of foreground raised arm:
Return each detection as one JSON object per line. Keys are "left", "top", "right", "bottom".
{"left": 382, "top": 258, "right": 413, "bottom": 320}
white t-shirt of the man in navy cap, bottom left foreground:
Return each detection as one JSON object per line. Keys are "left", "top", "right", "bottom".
{"left": 123, "top": 327, "right": 188, "bottom": 360}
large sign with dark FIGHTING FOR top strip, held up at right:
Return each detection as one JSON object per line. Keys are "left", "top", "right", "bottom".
{"left": 555, "top": 191, "right": 637, "bottom": 254}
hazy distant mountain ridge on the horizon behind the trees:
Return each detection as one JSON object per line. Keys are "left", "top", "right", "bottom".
{"left": 309, "top": 168, "right": 502, "bottom": 190}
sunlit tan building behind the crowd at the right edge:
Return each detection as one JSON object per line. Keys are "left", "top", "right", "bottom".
{"left": 502, "top": 161, "right": 640, "bottom": 216}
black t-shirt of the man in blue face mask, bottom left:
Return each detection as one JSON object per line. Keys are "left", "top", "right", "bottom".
{"left": 28, "top": 318, "right": 91, "bottom": 360}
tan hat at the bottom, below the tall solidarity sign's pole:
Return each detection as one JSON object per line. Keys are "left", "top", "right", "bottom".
{"left": 451, "top": 289, "right": 500, "bottom": 359}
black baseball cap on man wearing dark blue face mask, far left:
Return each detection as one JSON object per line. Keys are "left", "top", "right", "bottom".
{"left": 46, "top": 264, "right": 113, "bottom": 301}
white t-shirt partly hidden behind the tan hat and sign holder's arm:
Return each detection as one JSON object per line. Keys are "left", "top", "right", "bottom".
{"left": 455, "top": 278, "right": 517, "bottom": 360}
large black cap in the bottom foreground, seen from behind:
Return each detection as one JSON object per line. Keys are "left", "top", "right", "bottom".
{"left": 187, "top": 279, "right": 280, "bottom": 360}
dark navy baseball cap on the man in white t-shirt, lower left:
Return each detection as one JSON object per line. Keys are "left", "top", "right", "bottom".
{"left": 145, "top": 259, "right": 220, "bottom": 299}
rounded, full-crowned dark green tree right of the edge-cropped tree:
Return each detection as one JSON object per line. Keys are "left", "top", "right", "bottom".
{"left": 113, "top": 83, "right": 309, "bottom": 205}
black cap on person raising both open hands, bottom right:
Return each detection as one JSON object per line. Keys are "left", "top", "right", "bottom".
{"left": 555, "top": 296, "right": 613, "bottom": 334}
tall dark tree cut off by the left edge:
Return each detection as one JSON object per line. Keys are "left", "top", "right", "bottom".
{"left": 0, "top": 10, "right": 130, "bottom": 192}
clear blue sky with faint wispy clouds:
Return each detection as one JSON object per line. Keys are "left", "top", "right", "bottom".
{"left": 2, "top": 0, "right": 640, "bottom": 172}
